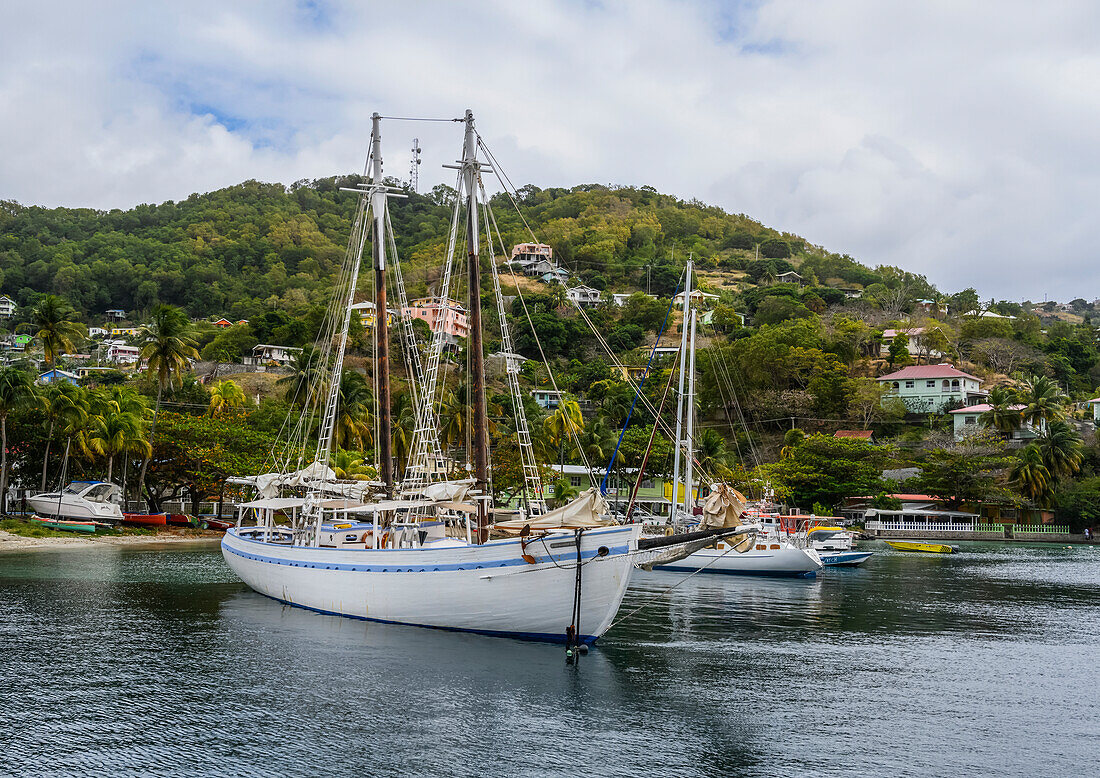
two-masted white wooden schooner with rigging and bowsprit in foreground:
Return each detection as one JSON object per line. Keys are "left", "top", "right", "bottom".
{"left": 221, "top": 111, "right": 734, "bottom": 644}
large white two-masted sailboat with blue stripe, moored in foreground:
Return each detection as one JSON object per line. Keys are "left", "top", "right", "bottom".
{"left": 222, "top": 111, "right": 641, "bottom": 643}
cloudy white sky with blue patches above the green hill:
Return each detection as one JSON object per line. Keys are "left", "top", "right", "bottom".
{"left": 0, "top": 0, "right": 1100, "bottom": 300}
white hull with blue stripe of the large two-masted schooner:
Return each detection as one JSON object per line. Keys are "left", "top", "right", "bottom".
{"left": 221, "top": 525, "right": 641, "bottom": 643}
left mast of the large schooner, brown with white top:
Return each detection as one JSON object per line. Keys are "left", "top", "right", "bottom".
{"left": 371, "top": 113, "right": 394, "bottom": 497}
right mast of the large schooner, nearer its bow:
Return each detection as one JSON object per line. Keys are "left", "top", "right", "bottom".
{"left": 462, "top": 110, "right": 488, "bottom": 543}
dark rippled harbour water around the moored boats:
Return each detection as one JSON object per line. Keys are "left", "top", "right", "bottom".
{"left": 0, "top": 544, "right": 1100, "bottom": 778}
